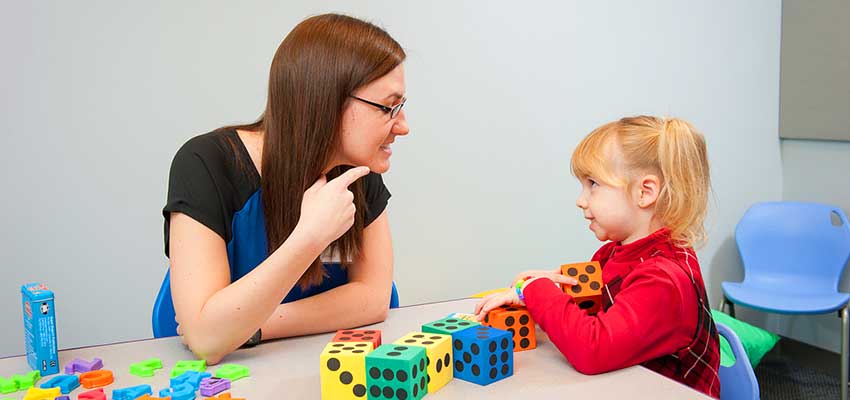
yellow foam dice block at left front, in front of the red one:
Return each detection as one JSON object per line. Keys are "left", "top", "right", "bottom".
{"left": 319, "top": 342, "right": 373, "bottom": 400}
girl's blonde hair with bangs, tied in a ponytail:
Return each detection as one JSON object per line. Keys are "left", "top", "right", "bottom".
{"left": 570, "top": 115, "right": 711, "bottom": 247}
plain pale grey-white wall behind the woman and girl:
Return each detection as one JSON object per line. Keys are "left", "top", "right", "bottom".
{"left": 0, "top": 0, "right": 782, "bottom": 356}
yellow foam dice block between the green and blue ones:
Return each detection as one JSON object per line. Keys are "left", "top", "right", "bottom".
{"left": 393, "top": 332, "right": 454, "bottom": 393}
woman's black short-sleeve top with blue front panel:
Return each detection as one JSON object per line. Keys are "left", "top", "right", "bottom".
{"left": 162, "top": 129, "right": 390, "bottom": 303}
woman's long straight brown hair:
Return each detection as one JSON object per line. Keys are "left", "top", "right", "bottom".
{"left": 227, "top": 14, "right": 406, "bottom": 288}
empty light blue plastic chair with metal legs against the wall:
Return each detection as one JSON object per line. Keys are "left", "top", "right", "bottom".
{"left": 720, "top": 202, "right": 850, "bottom": 400}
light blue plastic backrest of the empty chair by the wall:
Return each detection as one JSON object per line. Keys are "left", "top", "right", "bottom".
{"left": 735, "top": 202, "right": 850, "bottom": 294}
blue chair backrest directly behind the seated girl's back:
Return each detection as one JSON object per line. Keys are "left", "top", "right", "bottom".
{"left": 715, "top": 322, "right": 759, "bottom": 400}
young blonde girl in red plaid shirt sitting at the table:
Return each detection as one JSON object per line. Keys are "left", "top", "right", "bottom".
{"left": 475, "top": 116, "right": 720, "bottom": 398}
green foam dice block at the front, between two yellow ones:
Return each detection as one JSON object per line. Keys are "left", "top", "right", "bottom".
{"left": 366, "top": 344, "right": 428, "bottom": 400}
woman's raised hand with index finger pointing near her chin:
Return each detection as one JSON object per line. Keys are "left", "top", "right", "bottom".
{"left": 295, "top": 167, "right": 369, "bottom": 248}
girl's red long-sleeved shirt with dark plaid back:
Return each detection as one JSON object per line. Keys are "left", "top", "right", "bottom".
{"left": 523, "top": 229, "right": 720, "bottom": 398}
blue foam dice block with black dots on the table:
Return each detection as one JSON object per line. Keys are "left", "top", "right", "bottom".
{"left": 452, "top": 326, "right": 514, "bottom": 385}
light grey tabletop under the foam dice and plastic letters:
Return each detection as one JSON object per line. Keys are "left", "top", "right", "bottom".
{"left": 0, "top": 299, "right": 709, "bottom": 400}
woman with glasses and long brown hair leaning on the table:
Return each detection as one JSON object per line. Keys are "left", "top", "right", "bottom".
{"left": 163, "top": 14, "right": 408, "bottom": 364}
